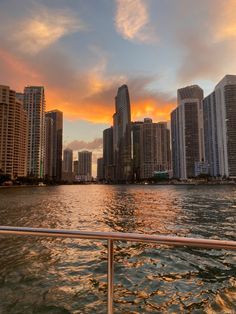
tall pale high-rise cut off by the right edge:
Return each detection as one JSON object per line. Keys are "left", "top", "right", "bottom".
{"left": 203, "top": 75, "right": 236, "bottom": 178}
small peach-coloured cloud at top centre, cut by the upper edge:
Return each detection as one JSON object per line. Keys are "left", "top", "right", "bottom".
{"left": 115, "top": 0, "right": 157, "bottom": 43}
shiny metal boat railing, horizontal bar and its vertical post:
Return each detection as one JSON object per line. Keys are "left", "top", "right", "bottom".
{"left": 0, "top": 226, "right": 236, "bottom": 314}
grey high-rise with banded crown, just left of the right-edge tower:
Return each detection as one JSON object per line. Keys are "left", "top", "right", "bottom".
{"left": 171, "top": 85, "right": 205, "bottom": 179}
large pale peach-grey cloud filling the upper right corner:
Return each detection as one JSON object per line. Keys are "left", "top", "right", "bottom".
{"left": 175, "top": 0, "right": 236, "bottom": 84}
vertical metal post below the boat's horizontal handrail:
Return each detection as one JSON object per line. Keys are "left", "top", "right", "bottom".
{"left": 107, "top": 239, "right": 114, "bottom": 314}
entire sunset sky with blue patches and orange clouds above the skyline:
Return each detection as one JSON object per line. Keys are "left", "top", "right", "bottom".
{"left": 0, "top": 0, "right": 236, "bottom": 171}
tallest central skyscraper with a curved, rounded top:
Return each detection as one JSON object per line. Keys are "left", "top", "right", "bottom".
{"left": 113, "top": 85, "right": 132, "bottom": 182}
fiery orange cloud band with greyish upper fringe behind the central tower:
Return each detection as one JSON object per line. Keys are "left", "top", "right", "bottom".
{"left": 0, "top": 49, "right": 174, "bottom": 124}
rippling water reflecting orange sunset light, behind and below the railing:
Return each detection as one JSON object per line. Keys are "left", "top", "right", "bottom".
{"left": 0, "top": 185, "right": 236, "bottom": 314}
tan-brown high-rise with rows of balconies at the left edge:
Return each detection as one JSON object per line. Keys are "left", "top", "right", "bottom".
{"left": 0, "top": 85, "right": 27, "bottom": 179}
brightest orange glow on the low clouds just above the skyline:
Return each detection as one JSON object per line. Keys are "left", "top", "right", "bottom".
{"left": 0, "top": 49, "right": 175, "bottom": 124}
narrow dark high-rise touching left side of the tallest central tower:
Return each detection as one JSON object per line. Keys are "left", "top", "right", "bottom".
{"left": 103, "top": 127, "right": 114, "bottom": 181}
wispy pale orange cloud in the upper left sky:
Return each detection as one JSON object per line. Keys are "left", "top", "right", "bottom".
{"left": 0, "top": 2, "right": 85, "bottom": 55}
